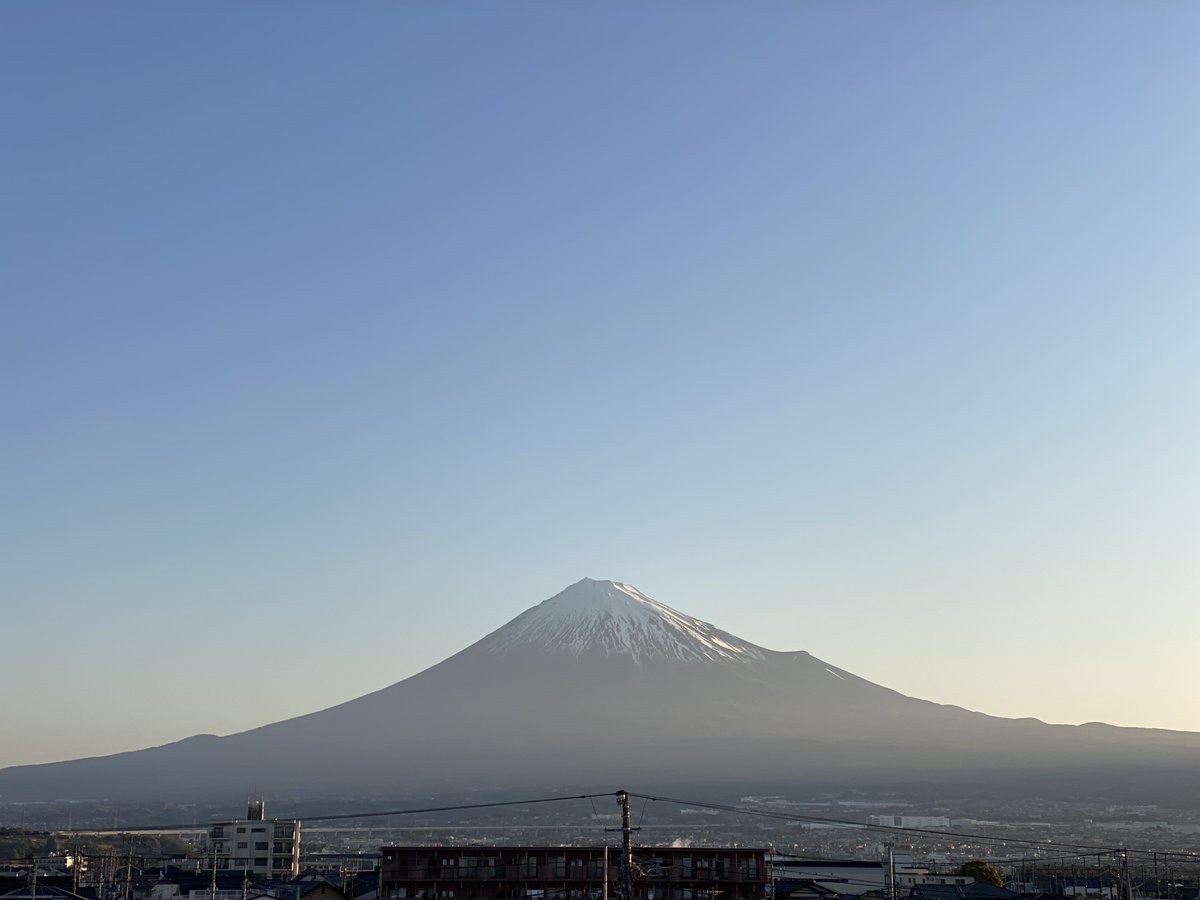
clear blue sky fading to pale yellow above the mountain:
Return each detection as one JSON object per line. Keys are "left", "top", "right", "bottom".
{"left": 0, "top": 1, "right": 1200, "bottom": 764}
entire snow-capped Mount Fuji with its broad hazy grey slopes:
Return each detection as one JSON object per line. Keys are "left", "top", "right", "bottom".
{"left": 0, "top": 578, "right": 1200, "bottom": 805}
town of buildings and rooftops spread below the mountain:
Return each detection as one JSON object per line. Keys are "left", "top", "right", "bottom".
{"left": 0, "top": 794, "right": 1200, "bottom": 900}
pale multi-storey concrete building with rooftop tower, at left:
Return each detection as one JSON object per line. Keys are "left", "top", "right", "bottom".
{"left": 205, "top": 800, "right": 300, "bottom": 878}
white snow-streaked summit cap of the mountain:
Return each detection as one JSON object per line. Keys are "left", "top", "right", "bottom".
{"left": 475, "top": 578, "right": 763, "bottom": 662}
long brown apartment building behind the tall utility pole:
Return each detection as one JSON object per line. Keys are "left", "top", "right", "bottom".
{"left": 379, "top": 847, "right": 767, "bottom": 900}
